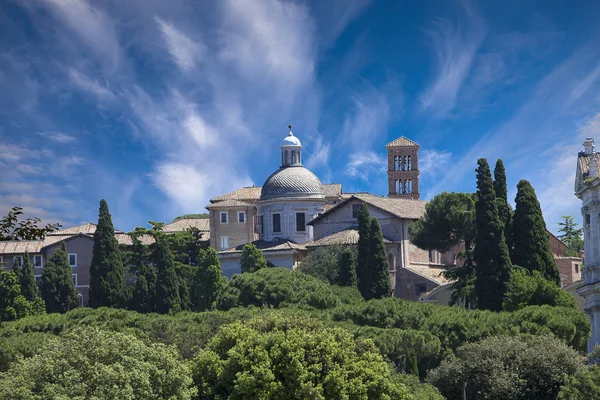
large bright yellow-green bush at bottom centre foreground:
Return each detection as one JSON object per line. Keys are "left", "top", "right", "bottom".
{"left": 193, "top": 317, "right": 409, "bottom": 399}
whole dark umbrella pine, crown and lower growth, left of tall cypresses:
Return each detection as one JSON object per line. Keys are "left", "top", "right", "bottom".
{"left": 408, "top": 192, "right": 475, "bottom": 308}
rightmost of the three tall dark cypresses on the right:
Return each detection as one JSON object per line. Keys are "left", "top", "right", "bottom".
{"left": 513, "top": 180, "right": 560, "bottom": 285}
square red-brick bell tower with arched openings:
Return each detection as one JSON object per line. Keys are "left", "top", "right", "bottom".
{"left": 385, "top": 136, "right": 421, "bottom": 200}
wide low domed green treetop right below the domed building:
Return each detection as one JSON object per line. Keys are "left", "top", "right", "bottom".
{"left": 217, "top": 267, "right": 340, "bottom": 310}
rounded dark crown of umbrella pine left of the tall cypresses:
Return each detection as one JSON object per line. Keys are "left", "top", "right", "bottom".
{"left": 408, "top": 192, "right": 475, "bottom": 253}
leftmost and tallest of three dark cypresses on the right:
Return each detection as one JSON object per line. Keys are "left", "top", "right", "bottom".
{"left": 474, "top": 158, "right": 512, "bottom": 311}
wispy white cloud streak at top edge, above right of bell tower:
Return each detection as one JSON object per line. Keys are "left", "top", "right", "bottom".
{"left": 421, "top": 2, "right": 486, "bottom": 118}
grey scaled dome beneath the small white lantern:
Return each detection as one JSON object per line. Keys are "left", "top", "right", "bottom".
{"left": 260, "top": 165, "right": 325, "bottom": 200}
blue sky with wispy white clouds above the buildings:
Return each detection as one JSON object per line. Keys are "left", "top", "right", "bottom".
{"left": 0, "top": 0, "right": 600, "bottom": 231}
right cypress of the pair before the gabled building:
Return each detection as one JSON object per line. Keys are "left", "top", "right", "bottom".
{"left": 367, "top": 218, "right": 392, "bottom": 300}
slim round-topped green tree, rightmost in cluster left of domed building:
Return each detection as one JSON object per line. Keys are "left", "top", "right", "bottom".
{"left": 192, "top": 247, "right": 227, "bottom": 311}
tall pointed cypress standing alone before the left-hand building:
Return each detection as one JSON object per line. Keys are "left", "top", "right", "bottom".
{"left": 89, "top": 199, "right": 127, "bottom": 308}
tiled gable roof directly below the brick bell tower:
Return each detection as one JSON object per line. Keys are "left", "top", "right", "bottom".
{"left": 308, "top": 193, "right": 427, "bottom": 225}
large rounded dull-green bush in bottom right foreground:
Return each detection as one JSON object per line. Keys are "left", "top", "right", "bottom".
{"left": 427, "top": 336, "right": 583, "bottom": 400}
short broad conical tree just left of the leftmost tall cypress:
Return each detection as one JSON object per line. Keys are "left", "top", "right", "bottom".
{"left": 40, "top": 242, "right": 79, "bottom": 313}
